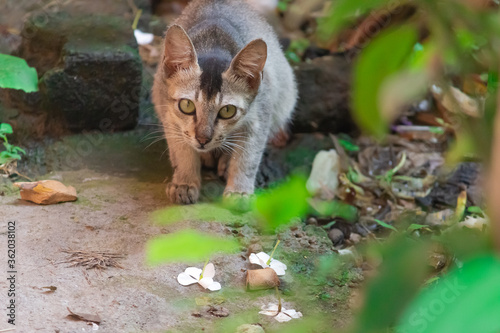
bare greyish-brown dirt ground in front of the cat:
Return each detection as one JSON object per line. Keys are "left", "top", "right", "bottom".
{"left": 0, "top": 131, "right": 350, "bottom": 333}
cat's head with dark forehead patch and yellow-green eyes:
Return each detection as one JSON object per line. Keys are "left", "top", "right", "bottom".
{"left": 160, "top": 25, "right": 267, "bottom": 151}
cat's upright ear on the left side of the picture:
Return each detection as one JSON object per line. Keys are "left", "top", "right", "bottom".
{"left": 163, "top": 24, "right": 198, "bottom": 77}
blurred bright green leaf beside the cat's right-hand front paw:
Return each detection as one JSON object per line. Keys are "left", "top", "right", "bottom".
{"left": 255, "top": 176, "right": 309, "bottom": 232}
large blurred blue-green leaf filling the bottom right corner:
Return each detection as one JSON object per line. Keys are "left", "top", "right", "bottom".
{"left": 397, "top": 255, "right": 500, "bottom": 333}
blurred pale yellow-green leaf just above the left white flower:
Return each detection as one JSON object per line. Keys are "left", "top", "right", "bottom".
{"left": 146, "top": 229, "right": 240, "bottom": 265}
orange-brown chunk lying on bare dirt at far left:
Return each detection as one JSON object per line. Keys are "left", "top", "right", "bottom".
{"left": 14, "top": 180, "right": 77, "bottom": 205}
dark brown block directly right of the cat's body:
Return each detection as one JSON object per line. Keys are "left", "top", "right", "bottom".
{"left": 292, "top": 55, "right": 356, "bottom": 133}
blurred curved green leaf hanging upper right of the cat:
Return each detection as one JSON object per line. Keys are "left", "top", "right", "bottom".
{"left": 352, "top": 26, "right": 417, "bottom": 138}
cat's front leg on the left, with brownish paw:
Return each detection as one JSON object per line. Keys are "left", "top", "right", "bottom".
{"left": 166, "top": 139, "right": 201, "bottom": 205}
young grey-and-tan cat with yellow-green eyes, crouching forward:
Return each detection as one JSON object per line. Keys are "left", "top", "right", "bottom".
{"left": 152, "top": 0, "right": 297, "bottom": 204}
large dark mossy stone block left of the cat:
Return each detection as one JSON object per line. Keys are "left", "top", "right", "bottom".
{"left": 10, "top": 12, "right": 142, "bottom": 131}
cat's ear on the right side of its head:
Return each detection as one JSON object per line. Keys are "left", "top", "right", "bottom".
{"left": 229, "top": 39, "right": 267, "bottom": 91}
